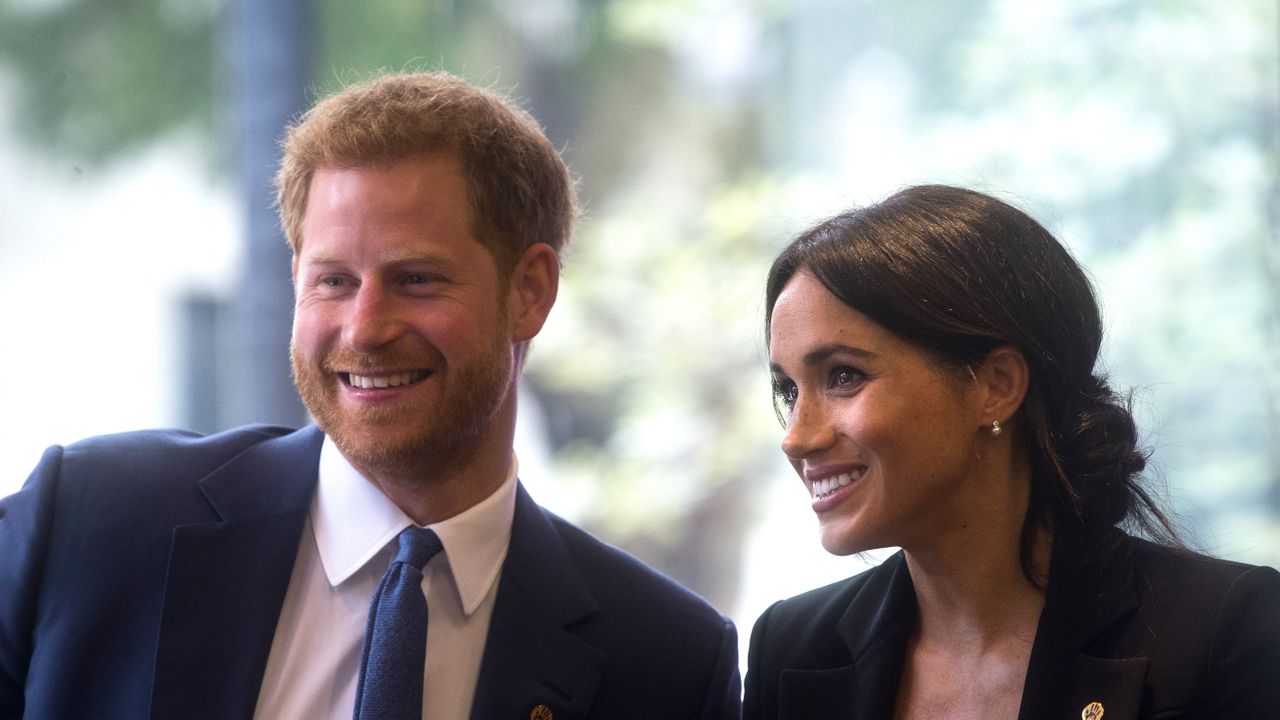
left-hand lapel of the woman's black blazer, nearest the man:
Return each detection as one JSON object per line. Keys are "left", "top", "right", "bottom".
{"left": 778, "top": 552, "right": 915, "bottom": 720}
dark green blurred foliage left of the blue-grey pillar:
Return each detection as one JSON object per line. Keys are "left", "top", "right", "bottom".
{"left": 0, "top": 0, "right": 220, "bottom": 164}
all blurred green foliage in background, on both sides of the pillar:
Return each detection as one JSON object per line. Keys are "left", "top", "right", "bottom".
{"left": 0, "top": 0, "right": 1280, "bottom": 606}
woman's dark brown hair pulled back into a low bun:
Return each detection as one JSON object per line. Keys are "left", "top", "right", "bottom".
{"left": 764, "top": 186, "right": 1178, "bottom": 577}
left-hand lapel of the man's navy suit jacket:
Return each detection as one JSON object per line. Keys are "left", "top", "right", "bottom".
{"left": 151, "top": 427, "right": 324, "bottom": 717}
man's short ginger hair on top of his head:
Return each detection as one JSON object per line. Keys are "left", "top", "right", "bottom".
{"left": 275, "top": 73, "right": 579, "bottom": 275}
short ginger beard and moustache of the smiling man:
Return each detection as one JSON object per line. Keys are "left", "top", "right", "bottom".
{"left": 289, "top": 302, "right": 515, "bottom": 477}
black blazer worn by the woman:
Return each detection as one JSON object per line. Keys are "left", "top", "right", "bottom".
{"left": 744, "top": 530, "right": 1280, "bottom": 720}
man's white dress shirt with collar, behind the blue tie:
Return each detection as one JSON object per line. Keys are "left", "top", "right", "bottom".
{"left": 246, "top": 437, "right": 516, "bottom": 720}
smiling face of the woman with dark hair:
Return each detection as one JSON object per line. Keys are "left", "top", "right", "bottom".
{"left": 769, "top": 272, "right": 991, "bottom": 555}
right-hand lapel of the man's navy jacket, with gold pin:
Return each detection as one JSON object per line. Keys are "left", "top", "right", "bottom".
{"left": 471, "top": 487, "right": 605, "bottom": 720}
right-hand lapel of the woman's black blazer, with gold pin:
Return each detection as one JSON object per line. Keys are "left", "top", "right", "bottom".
{"left": 1018, "top": 520, "right": 1149, "bottom": 720}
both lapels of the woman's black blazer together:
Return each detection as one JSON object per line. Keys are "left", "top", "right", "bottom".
{"left": 778, "top": 529, "right": 1148, "bottom": 720}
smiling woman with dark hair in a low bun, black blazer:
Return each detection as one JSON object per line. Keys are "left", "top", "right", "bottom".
{"left": 745, "top": 186, "right": 1280, "bottom": 720}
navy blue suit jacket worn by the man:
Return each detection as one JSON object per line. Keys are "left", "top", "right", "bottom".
{"left": 0, "top": 427, "right": 740, "bottom": 720}
